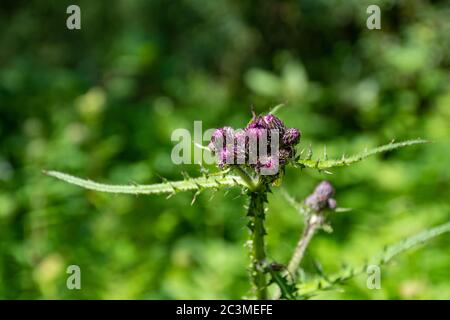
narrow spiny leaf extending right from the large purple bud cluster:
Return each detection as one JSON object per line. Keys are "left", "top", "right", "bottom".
{"left": 298, "top": 139, "right": 428, "bottom": 170}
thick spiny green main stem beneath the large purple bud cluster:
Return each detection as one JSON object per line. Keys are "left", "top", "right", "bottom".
{"left": 248, "top": 192, "right": 267, "bottom": 300}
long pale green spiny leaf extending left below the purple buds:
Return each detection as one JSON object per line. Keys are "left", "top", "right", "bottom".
{"left": 44, "top": 171, "right": 245, "bottom": 195}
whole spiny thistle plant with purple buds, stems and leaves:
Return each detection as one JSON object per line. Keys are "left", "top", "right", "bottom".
{"left": 45, "top": 109, "right": 450, "bottom": 299}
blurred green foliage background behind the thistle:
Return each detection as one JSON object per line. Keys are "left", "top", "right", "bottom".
{"left": 0, "top": 0, "right": 450, "bottom": 299}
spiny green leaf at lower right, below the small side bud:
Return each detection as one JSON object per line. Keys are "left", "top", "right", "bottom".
{"left": 297, "top": 222, "right": 450, "bottom": 298}
